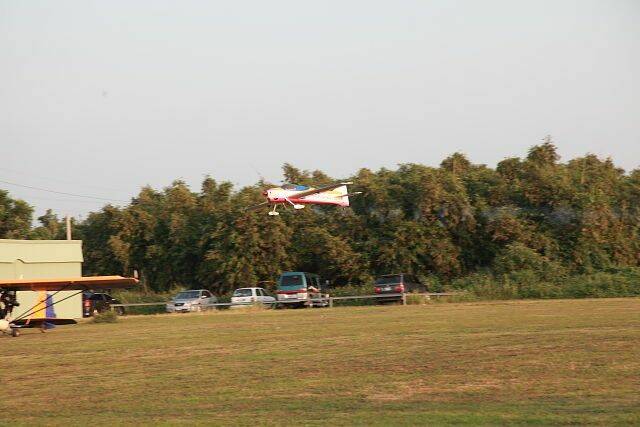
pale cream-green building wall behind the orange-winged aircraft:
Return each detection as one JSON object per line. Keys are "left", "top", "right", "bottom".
{"left": 0, "top": 239, "right": 83, "bottom": 319}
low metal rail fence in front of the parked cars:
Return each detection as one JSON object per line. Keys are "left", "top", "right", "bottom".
{"left": 110, "top": 292, "right": 460, "bottom": 310}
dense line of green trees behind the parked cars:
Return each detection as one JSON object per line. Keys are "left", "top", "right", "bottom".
{"left": 0, "top": 138, "right": 640, "bottom": 297}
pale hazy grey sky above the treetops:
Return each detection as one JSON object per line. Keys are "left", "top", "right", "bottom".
{"left": 0, "top": 0, "right": 640, "bottom": 221}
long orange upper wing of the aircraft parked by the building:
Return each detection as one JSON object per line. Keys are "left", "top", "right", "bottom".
{"left": 0, "top": 276, "right": 138, "bottom": 291}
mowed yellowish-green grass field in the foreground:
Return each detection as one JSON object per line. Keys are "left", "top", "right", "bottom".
{"left": 0, "top": 299, "right": 640, "bottom": 425}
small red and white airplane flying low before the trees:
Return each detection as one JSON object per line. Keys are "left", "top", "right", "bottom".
{"left": 248, "top": 182, "right": 360, "bottom": 215}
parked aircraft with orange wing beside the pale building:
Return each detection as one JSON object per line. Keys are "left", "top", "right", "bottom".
{"left": 0, "top": 276, "right": 138, "bottom": 337}
